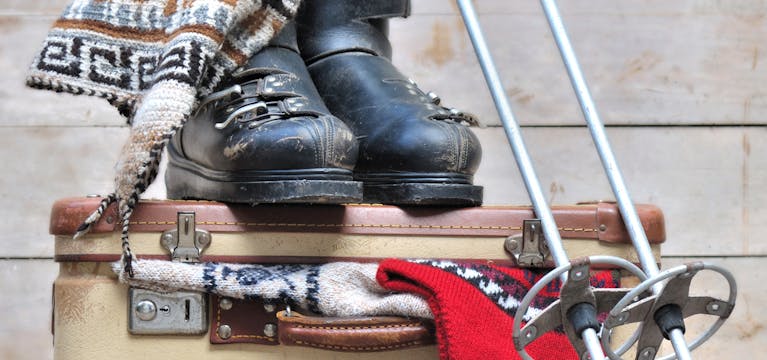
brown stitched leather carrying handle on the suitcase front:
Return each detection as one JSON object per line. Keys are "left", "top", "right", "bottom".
{"left": 277, "top": 311, "right": 435, "bottom": 352}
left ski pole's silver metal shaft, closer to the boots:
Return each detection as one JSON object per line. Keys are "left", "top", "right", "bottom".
{"left": 457, "top": 0, "right": 570, "bottom": 266}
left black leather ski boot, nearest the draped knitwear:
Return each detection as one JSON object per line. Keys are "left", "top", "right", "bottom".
{"left": 165, "top": 25, "right": 362, "bottom": 203}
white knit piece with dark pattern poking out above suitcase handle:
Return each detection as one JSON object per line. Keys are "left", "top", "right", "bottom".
{"left": 112, "top": 260, "right": 432, "bottom": 318}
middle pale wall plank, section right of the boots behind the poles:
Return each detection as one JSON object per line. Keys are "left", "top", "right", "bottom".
{"left": 476, "top": 127, "right": 767, "bottom": 256}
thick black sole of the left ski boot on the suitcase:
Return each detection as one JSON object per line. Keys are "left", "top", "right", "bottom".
{"left": 165, "top": 149, "right": 362, "bottom": 204}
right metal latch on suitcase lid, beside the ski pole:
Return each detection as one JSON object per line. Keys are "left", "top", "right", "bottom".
{"left": 504, "top": 219, "right": 550, "bottom": 267}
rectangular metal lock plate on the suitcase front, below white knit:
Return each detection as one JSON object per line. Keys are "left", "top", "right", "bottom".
{"left": 128, "top": 288, "right": 208, "bottom": 335}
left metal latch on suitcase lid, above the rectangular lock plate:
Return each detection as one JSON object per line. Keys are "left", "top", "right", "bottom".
{"left": 160, "top": 211, "right": 211, "bottom": 262}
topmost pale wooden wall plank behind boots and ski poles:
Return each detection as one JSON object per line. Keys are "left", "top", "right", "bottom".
{"left": 0, "top": 0, "right": 767, "bottom": 125}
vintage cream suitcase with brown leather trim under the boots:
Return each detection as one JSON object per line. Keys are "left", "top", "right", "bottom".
{"left": 50, "top": 198, "right": 665, "bottom": 359}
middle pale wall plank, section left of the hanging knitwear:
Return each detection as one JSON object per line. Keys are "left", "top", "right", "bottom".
{"left": 0, "top": 127, "right": 128, "bottom": 257}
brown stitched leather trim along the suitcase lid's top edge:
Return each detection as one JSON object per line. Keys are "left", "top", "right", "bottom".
{"left": 50, "top": 198, "right": 665, "bottom": 243}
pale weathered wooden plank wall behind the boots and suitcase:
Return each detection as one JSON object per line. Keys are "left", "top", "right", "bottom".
{"left": 0, "top": 0, "right": 767, "bottom": 359}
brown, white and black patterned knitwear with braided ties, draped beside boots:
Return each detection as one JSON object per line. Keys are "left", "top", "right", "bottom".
{"left": 27, "top": 0, "right": 300, "bottom": 276}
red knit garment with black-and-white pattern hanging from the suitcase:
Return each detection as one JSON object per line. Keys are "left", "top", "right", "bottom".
{"left": 377, "top": 260, "right": 619, "bottom": 360}
